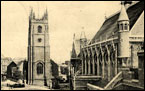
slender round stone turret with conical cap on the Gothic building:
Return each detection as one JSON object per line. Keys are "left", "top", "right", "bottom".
{"left": 118, "top": 1, "right": 130, "bottom": 64}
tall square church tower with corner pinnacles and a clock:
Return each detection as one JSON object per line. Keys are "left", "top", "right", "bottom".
{"left": 28, "top": 10, "right": 52, "bottom": 86}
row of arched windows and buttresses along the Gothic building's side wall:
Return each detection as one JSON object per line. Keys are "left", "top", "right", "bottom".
{"left": 81, "top": 39, "right": 118, "bottom": 81}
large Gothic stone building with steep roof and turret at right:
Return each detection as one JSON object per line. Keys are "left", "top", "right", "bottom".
{"left": 71, "top": 1, "right": 144, "bottom": 90}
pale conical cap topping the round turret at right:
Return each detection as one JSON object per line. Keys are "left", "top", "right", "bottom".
{"left": 118, "top": 1, "right": 129, "bottom": 21}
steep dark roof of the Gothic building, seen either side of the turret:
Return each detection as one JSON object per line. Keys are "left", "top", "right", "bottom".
{"left": 91, "top": 1, "right": 144, "bottom": 43}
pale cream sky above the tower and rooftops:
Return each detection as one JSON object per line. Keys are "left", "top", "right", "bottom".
{"left": 1, "top": 1, "right": 121, "bottom": 63}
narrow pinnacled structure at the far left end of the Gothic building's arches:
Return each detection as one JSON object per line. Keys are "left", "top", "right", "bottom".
{"left": 70, "top": 32, "right": 88, "bottom": 76}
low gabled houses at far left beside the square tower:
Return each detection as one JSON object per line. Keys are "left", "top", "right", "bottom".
{"left": 1, "top": 56, "right": 28, "bottom": 79}
